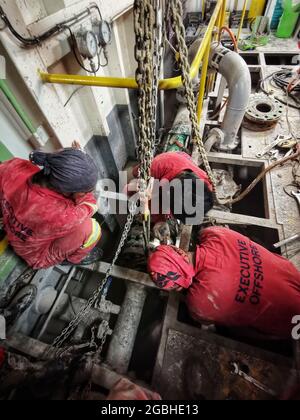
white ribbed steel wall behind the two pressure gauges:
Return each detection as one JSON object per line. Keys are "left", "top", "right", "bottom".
{"left": 0, "top": 0, "right": 136, "bottom": 150}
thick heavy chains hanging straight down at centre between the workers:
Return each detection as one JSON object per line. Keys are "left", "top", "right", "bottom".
{"left": 134, "top": 0, "right": 164, "bottom": 230}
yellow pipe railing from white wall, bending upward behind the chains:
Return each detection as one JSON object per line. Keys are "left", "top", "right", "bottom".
{"left": 40, "top": 0, "right": 226, "bottom": 90}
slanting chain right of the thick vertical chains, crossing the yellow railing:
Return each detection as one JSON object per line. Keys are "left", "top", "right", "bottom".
{"left": 166, "top": 0, "right": 216, "bottom": 191}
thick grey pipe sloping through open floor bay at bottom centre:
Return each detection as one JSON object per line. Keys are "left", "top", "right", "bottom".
{"left": 106, "top": 283, "right": 147, "bottom": 374}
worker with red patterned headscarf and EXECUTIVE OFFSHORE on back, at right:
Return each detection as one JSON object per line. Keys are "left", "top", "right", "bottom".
{"left": 148, "top": 227, "right": 300, "bottom": 339}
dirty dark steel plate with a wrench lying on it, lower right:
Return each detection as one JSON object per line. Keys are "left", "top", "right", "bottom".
{"left": 157, "top": 329, "right": 290, "bottom": 400}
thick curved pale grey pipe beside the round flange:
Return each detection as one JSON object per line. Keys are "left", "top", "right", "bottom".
{"left": 210, "top": 43, "right": 251, "bottom": 151}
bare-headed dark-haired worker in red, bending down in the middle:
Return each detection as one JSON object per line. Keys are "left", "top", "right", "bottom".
{"left": 127, "top": 152, "right": 213, "bottom": 224}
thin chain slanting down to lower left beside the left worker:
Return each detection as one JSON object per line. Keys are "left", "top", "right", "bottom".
{"left": 46, "top": 201, "right": 137, "bottom": 357}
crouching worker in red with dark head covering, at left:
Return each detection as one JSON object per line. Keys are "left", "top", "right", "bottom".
{"left": 0, "top": 143, "right": 102, "bottom": 269}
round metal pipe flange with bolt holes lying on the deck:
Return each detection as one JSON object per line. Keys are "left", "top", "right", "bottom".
{"left": 244, "top": 94, "right": 285, "bottom": 130}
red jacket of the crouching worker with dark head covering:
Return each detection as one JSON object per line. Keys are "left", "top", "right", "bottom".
{"left": 0, "top": 159, "right": 97, "bottom": 268}
